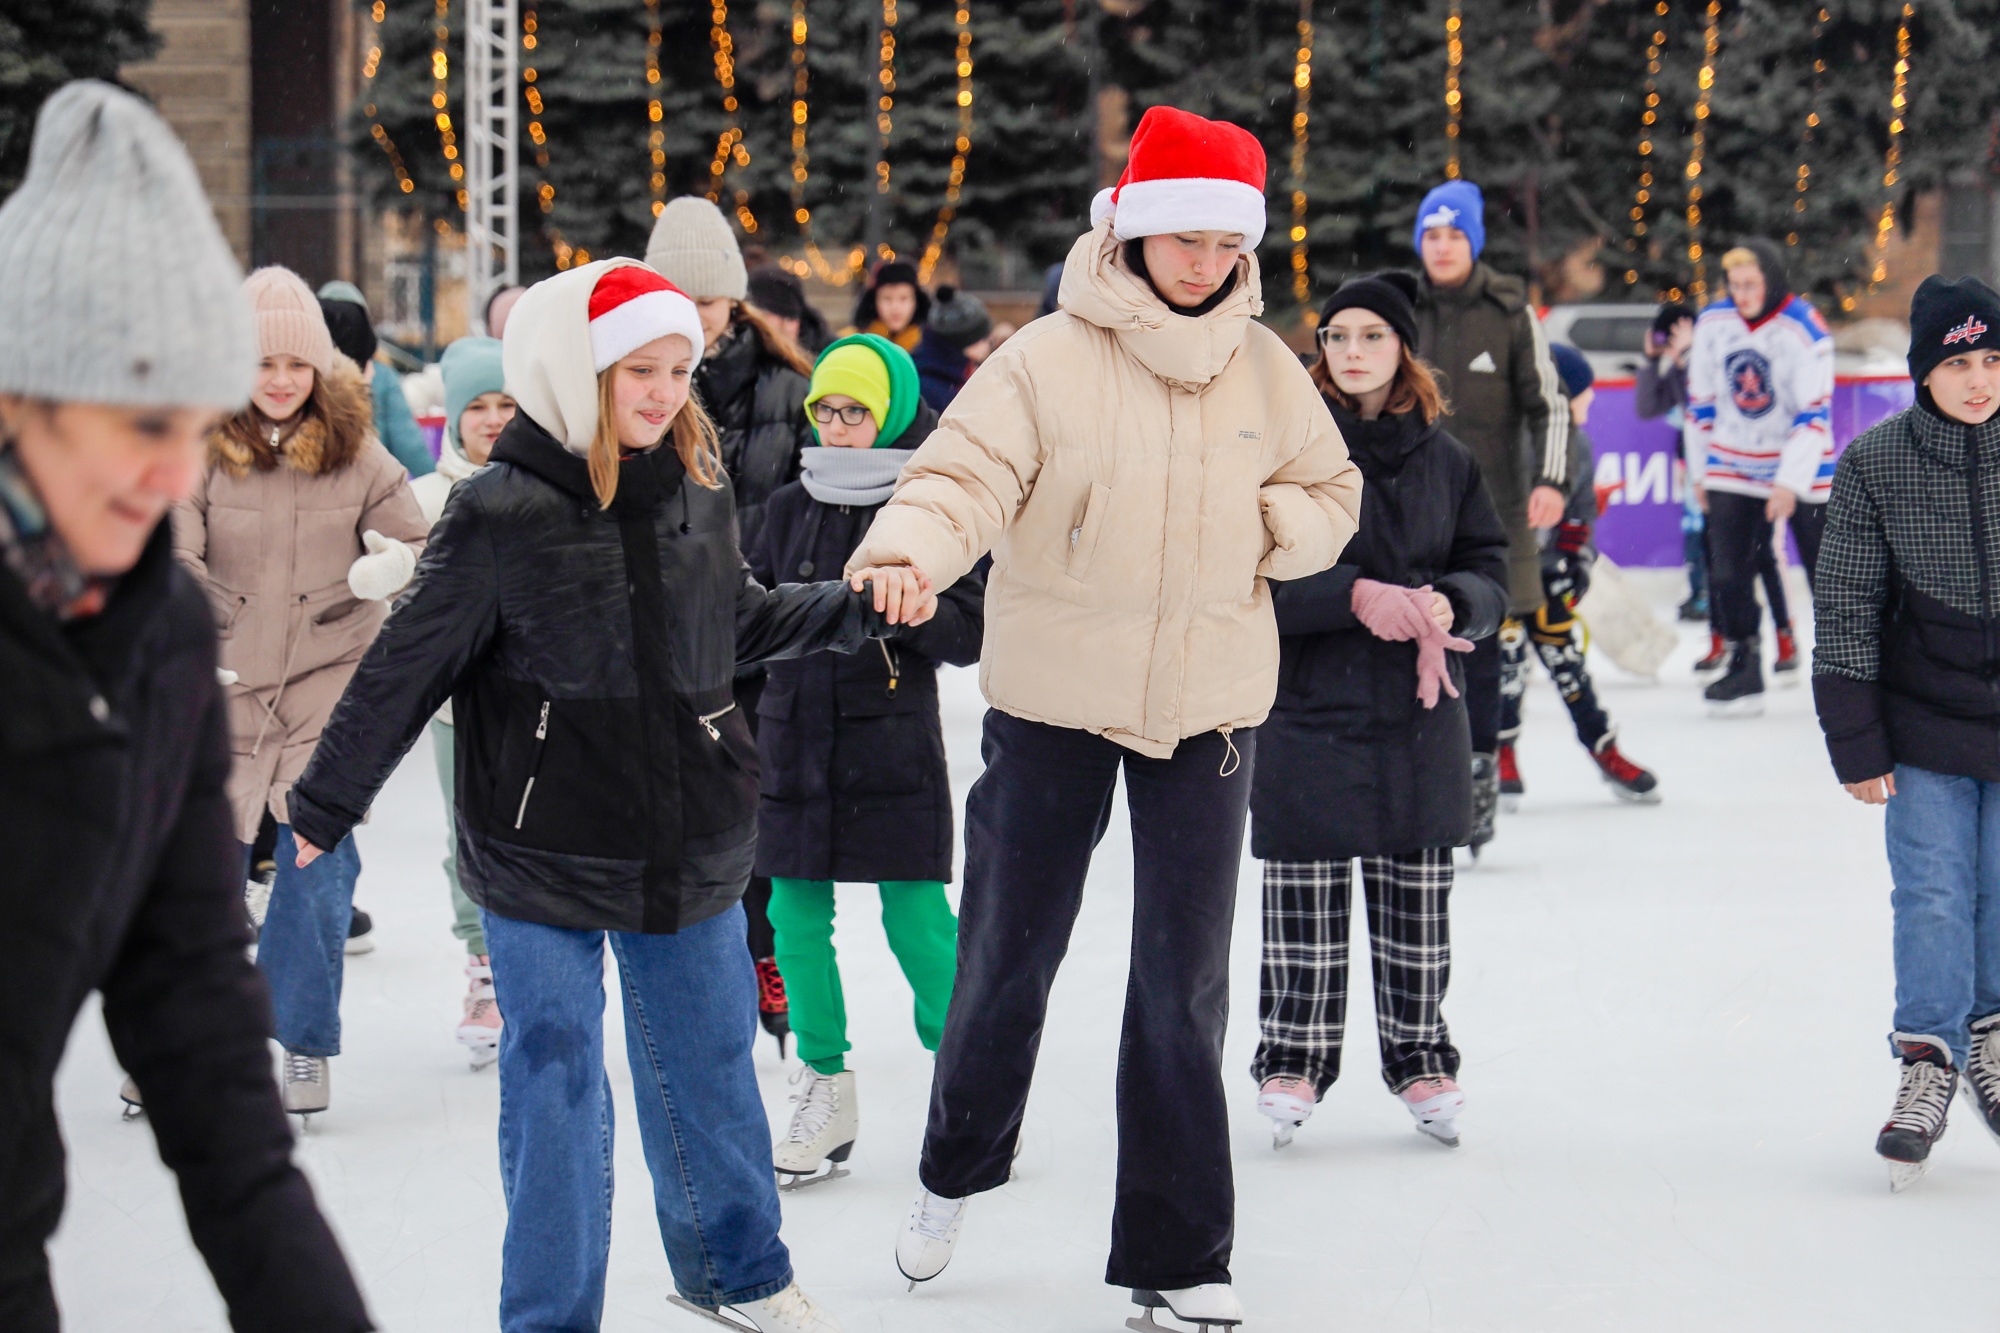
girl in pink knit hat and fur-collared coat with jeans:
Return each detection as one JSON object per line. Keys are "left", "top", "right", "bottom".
{"left": 174, "top": 268, "right": 426, "bottom": 1113}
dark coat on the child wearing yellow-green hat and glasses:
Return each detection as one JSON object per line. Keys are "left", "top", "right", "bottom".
{"left": 750, "top": 472, "right": 986, "bottom": 883}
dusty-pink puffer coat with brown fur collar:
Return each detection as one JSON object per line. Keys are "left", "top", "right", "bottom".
{"left": 174, "top": 358, "right": 428, "bottom": 843}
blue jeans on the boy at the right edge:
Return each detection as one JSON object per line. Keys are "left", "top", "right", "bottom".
{"left": 1886, "top": 765, "right": 2000, "bottom": 1069}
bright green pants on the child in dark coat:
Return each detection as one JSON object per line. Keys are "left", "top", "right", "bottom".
{"left": 770, "top": 879, "right": 958, "bottom": 1075}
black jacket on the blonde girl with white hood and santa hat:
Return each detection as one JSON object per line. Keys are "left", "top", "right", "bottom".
{"left": 292, "top": 414, "right": 876, "bottom": 933}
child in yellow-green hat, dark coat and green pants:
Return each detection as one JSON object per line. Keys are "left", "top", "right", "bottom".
{"left": 750, "top": 334, "right": 986, "bottom": 1187}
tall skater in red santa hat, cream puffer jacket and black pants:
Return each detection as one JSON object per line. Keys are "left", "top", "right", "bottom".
{"left": 868, "top": 108, "right": 1360, "bottom": 1321}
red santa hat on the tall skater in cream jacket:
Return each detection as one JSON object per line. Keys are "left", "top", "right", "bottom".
{"left": 1090, "top": 106, "right": 1264, "bottom": 250}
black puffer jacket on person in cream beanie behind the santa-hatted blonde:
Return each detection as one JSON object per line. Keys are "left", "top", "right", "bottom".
{"left": 694, "top": 320, "right": 808, "bottom": 556}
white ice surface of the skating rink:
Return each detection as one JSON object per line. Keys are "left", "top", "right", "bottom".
{"left": 43, "top": 578, "right": 2000, "bottom": 1333}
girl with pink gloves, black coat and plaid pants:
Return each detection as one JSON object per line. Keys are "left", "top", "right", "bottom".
{"left": 1250, "top": 272, "right": 1508, "bottom": 1147}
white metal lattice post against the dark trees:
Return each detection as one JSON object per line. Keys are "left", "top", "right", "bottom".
{"left": 466, "top": 0, "right": 520, "bottom": 332}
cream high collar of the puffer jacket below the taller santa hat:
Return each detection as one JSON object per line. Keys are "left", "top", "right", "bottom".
{"left": 1056, "top": 220, "right": 1264, "bottom": 388}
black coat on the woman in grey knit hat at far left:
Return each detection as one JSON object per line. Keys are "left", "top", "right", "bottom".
{"left": 0, "top": 522, "right": 370, "bottom": 1333}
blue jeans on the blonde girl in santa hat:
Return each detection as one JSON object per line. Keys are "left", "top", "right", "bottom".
{"left": 482, "top": 907, "right": 792, "bottom": 1333}
